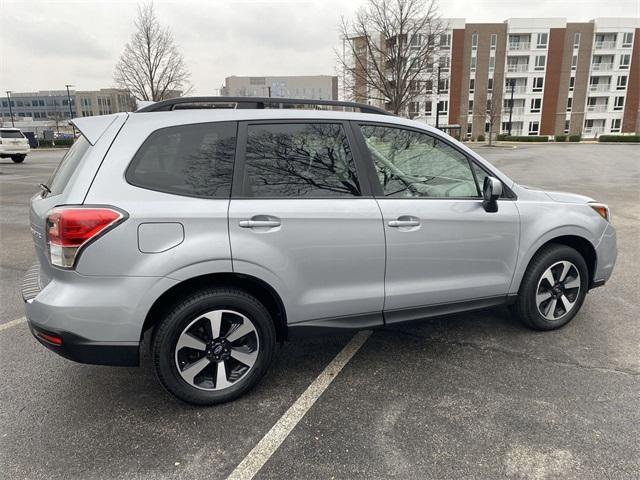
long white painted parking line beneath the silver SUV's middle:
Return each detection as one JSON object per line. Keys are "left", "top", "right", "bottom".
{"left": 227, "top": 330, "right": 371, "bottom": 480}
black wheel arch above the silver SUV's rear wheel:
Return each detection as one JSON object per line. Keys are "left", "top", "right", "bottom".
{"left": 140, "top": 272, "right": 288, "bottom": 342}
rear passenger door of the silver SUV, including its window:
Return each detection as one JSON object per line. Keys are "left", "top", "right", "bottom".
{"left": 229, "top": 120, "right": 385, "bottom": 327}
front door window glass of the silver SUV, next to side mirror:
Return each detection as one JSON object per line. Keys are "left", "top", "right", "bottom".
{"left": 360, "top": 125, "right": 480, "bottom": 198}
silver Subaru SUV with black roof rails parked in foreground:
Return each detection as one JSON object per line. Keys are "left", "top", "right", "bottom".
{"left": 23, "top": 98, "right": 616, "bottom": 404}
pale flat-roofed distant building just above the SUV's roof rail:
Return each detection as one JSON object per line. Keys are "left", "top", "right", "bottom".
{"left": 221, "top": 75, "right": 338, "bottom": 100}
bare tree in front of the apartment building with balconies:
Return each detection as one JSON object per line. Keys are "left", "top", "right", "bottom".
{"left": 337, "top": 0, "right": 445, "bottom": 114}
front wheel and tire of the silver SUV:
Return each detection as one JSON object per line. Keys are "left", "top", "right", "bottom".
{"left": 513, "top": 244, "right": 589, "bottom": 330}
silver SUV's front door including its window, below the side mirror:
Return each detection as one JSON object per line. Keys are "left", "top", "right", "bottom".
{"left": 354, "top": 124, "right": 519, "bottom": 323}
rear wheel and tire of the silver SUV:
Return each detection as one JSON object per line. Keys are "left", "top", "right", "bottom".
{"left": 151, "top": 288, "right": 276, "bottom": 405}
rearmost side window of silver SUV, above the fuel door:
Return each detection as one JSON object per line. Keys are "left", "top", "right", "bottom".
{"left": 126, "top": 122, "right": 236, "bottom": 198}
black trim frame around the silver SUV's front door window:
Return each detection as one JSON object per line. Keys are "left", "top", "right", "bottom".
{"left": 350, "top": 120, "right": 518, "bottom": 202}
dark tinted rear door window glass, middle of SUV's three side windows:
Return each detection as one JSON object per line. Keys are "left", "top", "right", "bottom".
{"left": 246, "top": 123, "right": 360, "bottom": 197}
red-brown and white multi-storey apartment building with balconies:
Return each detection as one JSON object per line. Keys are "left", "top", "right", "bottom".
{"left": 354, "top": 18, "right": 640, "bottom": 138}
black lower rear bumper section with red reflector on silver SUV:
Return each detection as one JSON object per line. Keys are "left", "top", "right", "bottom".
{"left": 27, "top": 320, "right": 140, "bottom": 367}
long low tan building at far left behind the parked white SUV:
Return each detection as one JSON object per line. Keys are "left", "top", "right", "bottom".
{"left": 0, "top": 88, "right": 136, "bottom": 124}
